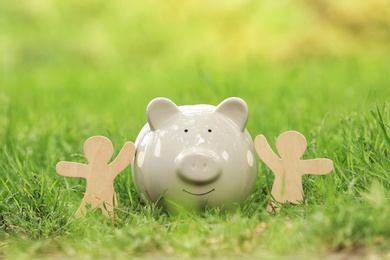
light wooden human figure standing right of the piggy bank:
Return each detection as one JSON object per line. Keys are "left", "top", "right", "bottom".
{"left": 255, "top": 131, "right": 333, "bottom": 210}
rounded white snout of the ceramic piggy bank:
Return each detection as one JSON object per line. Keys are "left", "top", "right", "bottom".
{"left": 176, "top": 151, "right": 222, "bottom": 184}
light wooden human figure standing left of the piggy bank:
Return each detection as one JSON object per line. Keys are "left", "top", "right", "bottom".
{"left": 56, "top": 136, "right": 135, "bottom": 218}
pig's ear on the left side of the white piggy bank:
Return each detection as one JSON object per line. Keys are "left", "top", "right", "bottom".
{"left": 146, "top": 98, "right": 180, "bottom": 131}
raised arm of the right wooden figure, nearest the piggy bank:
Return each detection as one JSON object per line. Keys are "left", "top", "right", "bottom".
{"left": 255, "top": 135, "right": 281, "bottom": 174}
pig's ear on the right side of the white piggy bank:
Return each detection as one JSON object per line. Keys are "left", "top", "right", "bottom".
{"left": 215, "top": 97, "right": 248, "bottom": 132}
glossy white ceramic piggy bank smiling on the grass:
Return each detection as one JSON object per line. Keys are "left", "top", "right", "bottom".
{"left": 132, "top": 98, "right": 257, "bottom": 211}
